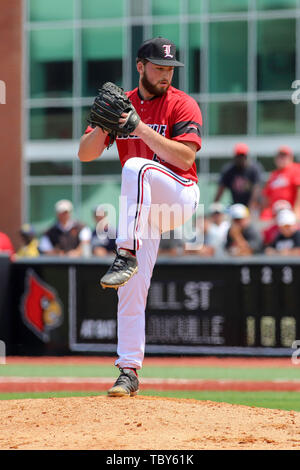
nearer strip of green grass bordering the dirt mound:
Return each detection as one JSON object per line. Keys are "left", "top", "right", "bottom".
{"left": 0, "top": 390, "right": 300, "bottom": 411}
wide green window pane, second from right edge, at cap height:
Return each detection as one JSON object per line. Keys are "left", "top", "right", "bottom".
{"left": 209, "top": 21, "right": 248, "bottom": 93}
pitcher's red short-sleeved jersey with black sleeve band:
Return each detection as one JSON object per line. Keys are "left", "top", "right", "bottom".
{"left": 85, "top": 86, "right": 202, "bottom": 182}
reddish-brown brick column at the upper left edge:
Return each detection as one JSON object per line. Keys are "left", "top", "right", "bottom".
{"left": 0, "top": 0, "right": 24, "bottom": 248}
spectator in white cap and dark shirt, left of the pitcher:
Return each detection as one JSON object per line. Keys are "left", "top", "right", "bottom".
{"left": 39, "top": 199, "right": 91, "bottom": 257}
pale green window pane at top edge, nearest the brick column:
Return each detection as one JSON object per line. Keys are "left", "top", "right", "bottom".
{"left": 29, "top": 0, "right": 74, "bottom": 21}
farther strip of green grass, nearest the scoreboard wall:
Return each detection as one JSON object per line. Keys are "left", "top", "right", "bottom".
{"left": 0, "top": 364, "right": 300, "bottom": 380}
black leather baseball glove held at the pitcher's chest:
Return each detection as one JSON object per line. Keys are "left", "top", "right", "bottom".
{"left": 88, "top": 82, "right": 140, "bottom": 147}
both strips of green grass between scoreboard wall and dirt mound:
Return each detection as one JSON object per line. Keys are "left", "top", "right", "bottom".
{"left": 0, "top": 360, "right": 300, "bottom": 411}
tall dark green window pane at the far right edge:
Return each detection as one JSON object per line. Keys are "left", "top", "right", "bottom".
{"left": 257, "top": 19, "right": 296, "bottom": 91}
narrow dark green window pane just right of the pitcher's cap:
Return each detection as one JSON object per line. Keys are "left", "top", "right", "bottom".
{"left": 187, "top": 23, "right": 202, "bottom": 93}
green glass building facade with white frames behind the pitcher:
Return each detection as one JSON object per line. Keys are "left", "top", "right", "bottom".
{"left": 24, "top": 0, "right": 300, "bottom": 232}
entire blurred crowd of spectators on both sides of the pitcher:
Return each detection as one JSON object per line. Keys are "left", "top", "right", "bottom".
{"left": 0, "top": 143, "right": 300, "bottom": 259}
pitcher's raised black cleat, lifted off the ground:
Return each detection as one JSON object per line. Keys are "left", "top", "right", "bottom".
{"left": 100, "top": 248, "right": 138, "bottom": 289}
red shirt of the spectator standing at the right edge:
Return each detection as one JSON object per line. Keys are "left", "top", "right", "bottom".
{"left": 261, "top": 163, "right": 300, "bottom": 219}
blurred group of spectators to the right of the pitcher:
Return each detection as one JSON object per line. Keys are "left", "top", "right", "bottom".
{"left": 160, "top": 143, "right": 300, "bottom": 257}
